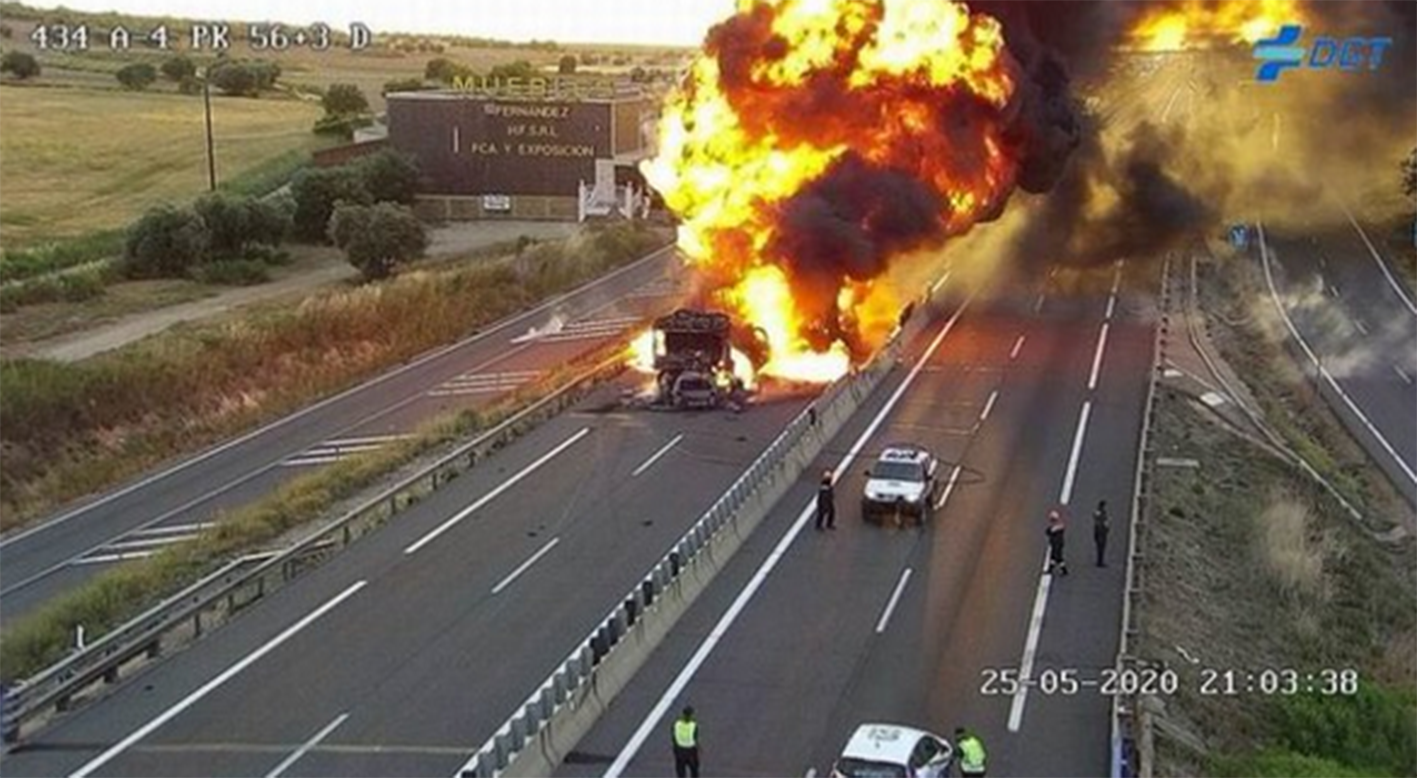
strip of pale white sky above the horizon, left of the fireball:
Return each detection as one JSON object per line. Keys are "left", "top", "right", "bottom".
{"left": 44, "top": 0, "right": 734, "bottom": 45}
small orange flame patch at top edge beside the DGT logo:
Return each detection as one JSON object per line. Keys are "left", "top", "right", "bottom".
{"left": 1132, "top": 0, "right": 1306, "bottom": 51}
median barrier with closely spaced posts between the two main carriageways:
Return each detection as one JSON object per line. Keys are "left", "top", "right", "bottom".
{"left": 459, "top": 285, "right": 938, "bottom": 778}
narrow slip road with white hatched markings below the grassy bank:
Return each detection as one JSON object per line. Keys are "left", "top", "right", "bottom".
{"left": 0, "top": 249, "right": 680, "bottom": 625}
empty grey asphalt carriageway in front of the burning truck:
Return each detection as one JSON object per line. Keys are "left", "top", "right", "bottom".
{"left": 0, "top": 362, "right": 808, "bottom": 778}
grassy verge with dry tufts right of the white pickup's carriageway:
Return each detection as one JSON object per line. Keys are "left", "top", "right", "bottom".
{"left": 1139, "top": 252, "right": 1417, "bottom": 778}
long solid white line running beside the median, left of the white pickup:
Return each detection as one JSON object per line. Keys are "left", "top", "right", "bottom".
{"left": 602, "top": 295, "right": 973, "bottom": 778}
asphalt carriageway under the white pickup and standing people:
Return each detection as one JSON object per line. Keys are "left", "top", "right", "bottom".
{"left": 557, "top": 262, "right": 1155, "bottom": 778}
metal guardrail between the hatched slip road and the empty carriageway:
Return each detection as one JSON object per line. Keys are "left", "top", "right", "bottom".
{"left": 0, "top": 347, "right": 623, "bottom": 743}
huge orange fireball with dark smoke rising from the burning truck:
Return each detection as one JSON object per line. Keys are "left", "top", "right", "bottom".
{"left": 645, "top": 0, "right": 1020, "bottom": 381}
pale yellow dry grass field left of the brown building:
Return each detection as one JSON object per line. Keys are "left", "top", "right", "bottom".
{"left": 0, "top": 81, "right": 322, "bottom": 247}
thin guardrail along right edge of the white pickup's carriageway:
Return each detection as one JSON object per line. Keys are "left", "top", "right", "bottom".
{"left": 1111, "top": 256, "right": 1170, "bottom": 778}
